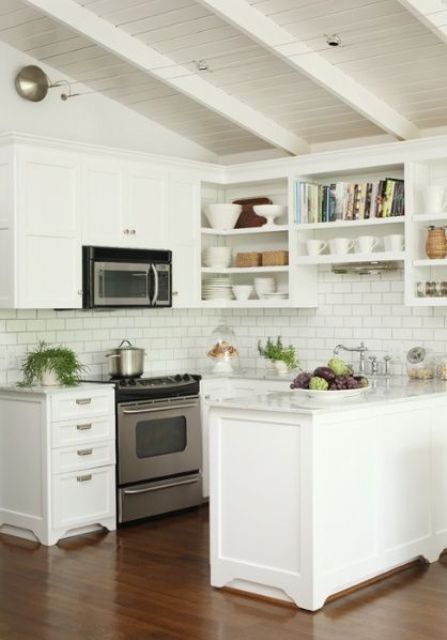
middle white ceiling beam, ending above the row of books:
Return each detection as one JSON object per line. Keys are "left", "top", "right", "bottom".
{"left": 198, "top": 0, "right": 419, "bottom": 140}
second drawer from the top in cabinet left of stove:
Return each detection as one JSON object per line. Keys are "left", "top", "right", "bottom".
{"left": 51, "top": 417, "right": 115, "bottom": 447}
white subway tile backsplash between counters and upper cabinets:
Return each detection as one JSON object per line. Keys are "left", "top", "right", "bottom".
{"left": 0, "top": 269, "right": 447, "bottom": 383}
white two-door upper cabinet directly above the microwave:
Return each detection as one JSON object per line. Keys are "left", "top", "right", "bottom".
{"left": 82, "top": 158, "right": 168, "bottom": 249}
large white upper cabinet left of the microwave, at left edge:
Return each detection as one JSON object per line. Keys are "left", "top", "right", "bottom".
{"left": 0, "top": 145, "right": 82, "bottom": 309}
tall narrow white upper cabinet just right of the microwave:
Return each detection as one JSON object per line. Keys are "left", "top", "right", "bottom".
{"left": 166, "top": 175, "right": 200, "bottom": 308}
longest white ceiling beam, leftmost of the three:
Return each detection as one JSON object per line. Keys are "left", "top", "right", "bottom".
{"left": 21, "top": 0, "right": 309, "bottom": 155}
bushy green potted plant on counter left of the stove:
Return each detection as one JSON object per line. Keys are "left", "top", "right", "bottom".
{"left": 21, "top": 342, "right": 85, "bottom": 387}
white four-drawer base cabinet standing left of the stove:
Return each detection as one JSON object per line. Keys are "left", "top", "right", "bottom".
{"left": 0, "top": 384, "right": 116, "bottom": 545}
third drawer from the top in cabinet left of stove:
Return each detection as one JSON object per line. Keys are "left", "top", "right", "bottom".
{"left": 51, "top": 440, "right": 115, "bottom": 473}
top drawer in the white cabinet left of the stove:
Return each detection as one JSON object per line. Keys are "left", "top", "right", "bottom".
{"left": 51, "top": 392, "right": 113, "bottom": 422}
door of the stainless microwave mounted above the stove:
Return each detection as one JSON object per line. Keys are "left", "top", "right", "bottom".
{"left": 93, "top": 262, "right": 154, "bottom": 307}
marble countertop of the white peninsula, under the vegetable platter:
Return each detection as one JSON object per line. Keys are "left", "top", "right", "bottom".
{"left": 210, "top": 376, "right": 447, "bottom": 413}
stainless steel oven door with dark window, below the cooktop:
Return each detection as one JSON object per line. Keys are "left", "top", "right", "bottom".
{"left": 118, "top": 397, "right": 202, "bottom": 485}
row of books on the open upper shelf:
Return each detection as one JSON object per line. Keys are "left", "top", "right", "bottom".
{"left": 294, "top": 178, "right": 405, "bottom": 224}
